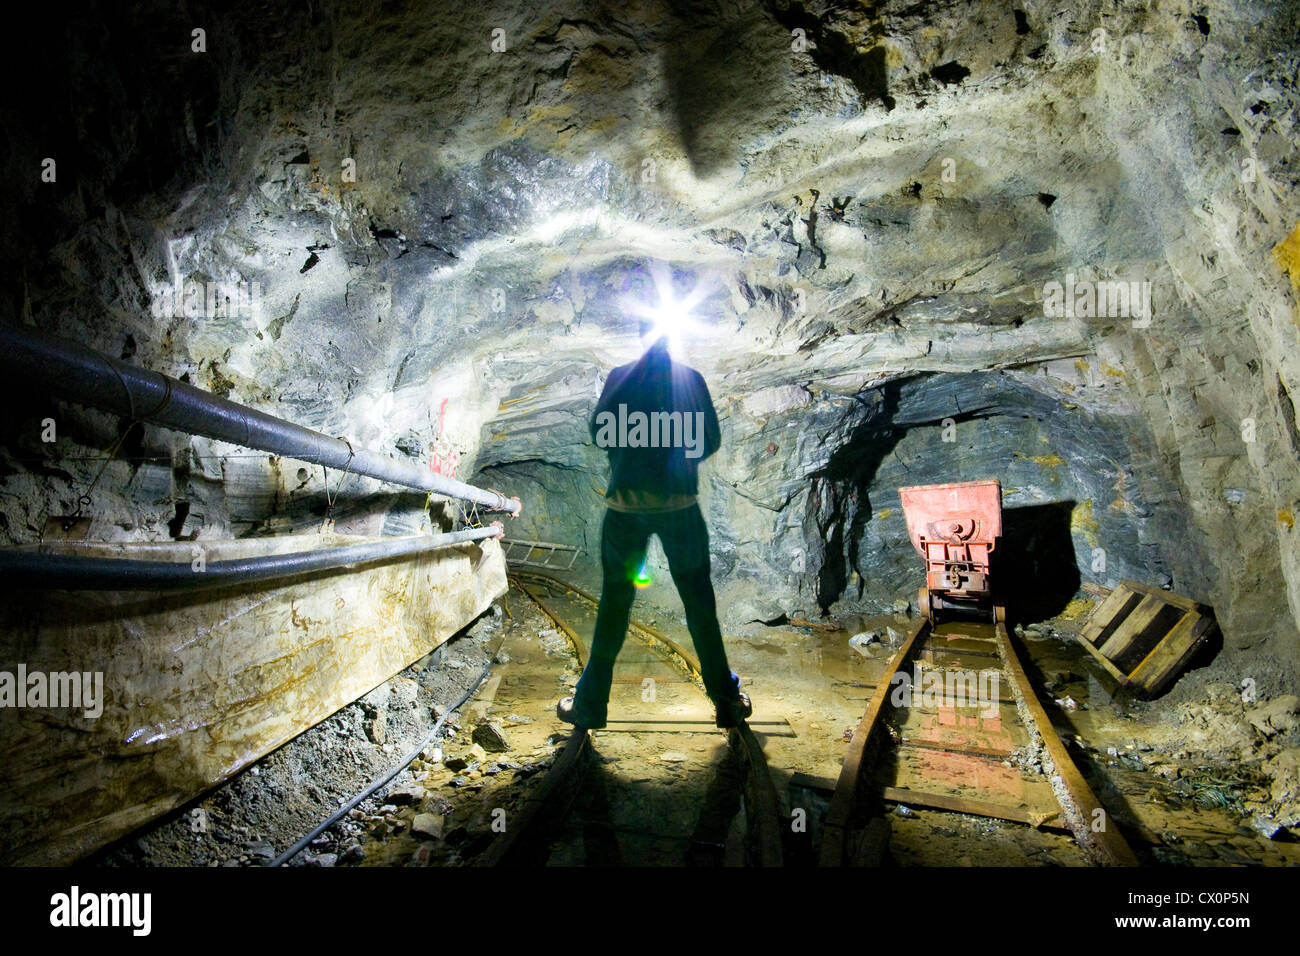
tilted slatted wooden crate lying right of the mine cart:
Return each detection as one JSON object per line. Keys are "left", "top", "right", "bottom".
{"left": 1079, "top": 580, "right": 1217, "bottom": 697}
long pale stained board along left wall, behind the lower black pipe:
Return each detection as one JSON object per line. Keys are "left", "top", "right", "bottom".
{"left": 0, "top": 532, "right": 506, "bottom": 866}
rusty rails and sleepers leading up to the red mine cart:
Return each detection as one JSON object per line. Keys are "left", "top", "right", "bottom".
{"left": 819, "top": 618, "right": 1138, "bottom": 866}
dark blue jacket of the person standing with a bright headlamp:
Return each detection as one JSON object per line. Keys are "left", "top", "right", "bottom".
{"left": 592, "top": 347, "right": 722, "bottom": 497}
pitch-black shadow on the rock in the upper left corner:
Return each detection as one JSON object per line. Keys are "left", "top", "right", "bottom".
{"left": 0, "top": 0, "right": 222, "bottom": 273}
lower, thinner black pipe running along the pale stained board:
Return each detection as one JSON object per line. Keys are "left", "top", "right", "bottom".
{"left": 0, "top": 522, "right": 503, "bottom": 591}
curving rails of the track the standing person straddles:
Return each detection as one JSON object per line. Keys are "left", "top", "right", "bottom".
{"left": 476, "top": 568, "right": 785, "bottom": 866}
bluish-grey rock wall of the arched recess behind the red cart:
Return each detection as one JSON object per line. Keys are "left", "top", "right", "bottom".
{"left": 805, "top": 363, "right": 1199, "bottom": 619}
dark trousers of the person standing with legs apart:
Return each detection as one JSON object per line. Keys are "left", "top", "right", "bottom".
{"left": 573, "top": 505, "right": 740, "bottom": 726}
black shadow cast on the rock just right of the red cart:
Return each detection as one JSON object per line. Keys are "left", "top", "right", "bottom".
{"left": 992, "top": 501, "right": 1082, "bottom": 627}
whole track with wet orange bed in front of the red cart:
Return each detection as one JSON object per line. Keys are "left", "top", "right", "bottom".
{"left": 819, "top": 609, "right": 1138, "bottom": 866}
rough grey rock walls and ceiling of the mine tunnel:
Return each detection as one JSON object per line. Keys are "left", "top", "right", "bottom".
{"left": 0, "top": 0, "right": 1300, "bottom": 693}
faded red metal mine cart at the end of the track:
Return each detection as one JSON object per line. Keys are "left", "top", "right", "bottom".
{"left": 898, "top": 479, "right": 1002, "bottom": 620}
